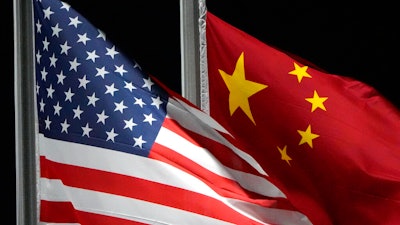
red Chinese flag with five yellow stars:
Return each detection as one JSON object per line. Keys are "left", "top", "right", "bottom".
{"left": 202, "top": 12, "right": 400, "bottom": 225}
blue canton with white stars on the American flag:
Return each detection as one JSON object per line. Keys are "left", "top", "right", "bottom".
{"left": 35, "top": 1, "right": 167, "bottom": 155}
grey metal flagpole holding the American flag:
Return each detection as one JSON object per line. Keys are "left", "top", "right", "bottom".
{"left": 13, "top": 0, "right": 38, "bottom": 225}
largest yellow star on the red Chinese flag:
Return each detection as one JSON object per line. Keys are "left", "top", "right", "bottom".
{"left": 218, "top": 52, "right": 267, "bottom": 124}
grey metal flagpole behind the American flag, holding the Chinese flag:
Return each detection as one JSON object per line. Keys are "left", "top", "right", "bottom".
{"left": 180, "top": 0, "right": 200, "bottom": 106}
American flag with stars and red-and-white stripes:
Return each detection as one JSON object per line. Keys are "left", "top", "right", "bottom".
{"left": 33, "top": 0, "right": 310, "bottom": 225}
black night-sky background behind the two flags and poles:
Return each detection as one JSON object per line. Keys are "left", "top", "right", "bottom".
{"left": 9, "top": 0, "right": 400, "bottom": 224}
